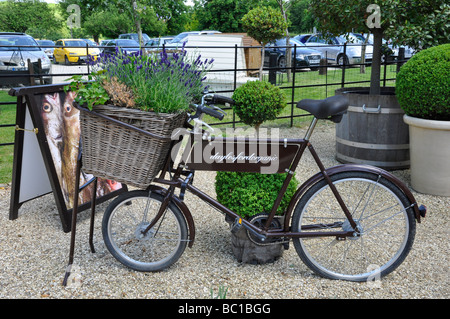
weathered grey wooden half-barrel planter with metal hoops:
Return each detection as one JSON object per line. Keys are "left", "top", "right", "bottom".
{"left": 336, "top": 87, "right": 410, "bottom": 170}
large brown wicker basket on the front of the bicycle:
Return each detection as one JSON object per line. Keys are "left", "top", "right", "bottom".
{"left": 80, "top": 105, "right": 186, "bottom": 188}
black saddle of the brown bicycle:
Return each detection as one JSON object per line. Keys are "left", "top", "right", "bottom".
{"left": 297, "top": 95, "right": 349, "bottom": 123}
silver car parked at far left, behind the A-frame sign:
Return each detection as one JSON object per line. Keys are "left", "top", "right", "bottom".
{"left": 0, "top": 32, "right": 52, "bottom": 83}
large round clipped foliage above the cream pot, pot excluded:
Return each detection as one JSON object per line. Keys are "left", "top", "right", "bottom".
{"left": 396, "top": 44, "right": 450, "bottom": 120}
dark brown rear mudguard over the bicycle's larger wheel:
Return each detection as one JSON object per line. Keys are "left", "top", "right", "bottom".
{"left": 285, "top": 164, "right": 426, "bottom": 229}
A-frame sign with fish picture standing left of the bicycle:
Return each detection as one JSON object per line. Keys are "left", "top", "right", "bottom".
{"left": 9, "top": 84, "right": 127, "bottom": 232}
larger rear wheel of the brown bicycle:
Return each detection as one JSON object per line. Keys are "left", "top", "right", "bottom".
{"left": 292, "top": 172, "right": 416, "bottom": 281}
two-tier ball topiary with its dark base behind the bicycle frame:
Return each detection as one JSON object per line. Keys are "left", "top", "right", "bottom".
{"left": 216, "top": 81, "right": 297, "bottom": 263}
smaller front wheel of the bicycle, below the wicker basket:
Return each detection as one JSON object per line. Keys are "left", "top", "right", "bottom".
{"left": 102, "top": 190, "right": 188, "bottom": 271}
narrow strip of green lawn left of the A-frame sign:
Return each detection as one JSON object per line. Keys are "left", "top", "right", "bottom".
{"left": 0, "top": 90, "right": 16, "bottom": 185}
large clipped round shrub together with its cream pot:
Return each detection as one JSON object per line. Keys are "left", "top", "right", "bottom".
{"left": 396, "top": 44, "right": 450, "bottom": 196}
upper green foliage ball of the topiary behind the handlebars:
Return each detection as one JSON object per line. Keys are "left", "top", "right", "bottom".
{"left": 233, "top": 81, "right": 286, "bottom": 128}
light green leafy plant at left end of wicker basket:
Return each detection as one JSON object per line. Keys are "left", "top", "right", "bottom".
{"left": 64, "top": 72, "right": 109, "bottom": 109}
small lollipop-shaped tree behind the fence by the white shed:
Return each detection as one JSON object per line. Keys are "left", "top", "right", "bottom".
{"left": 242, "top": 7, "right": 287, "bottom": 80}
